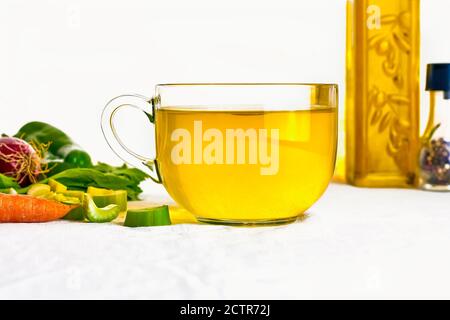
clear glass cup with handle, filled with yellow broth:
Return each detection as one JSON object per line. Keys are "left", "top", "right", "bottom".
{"left": 102, "top": 83, "right": 338, "bottom": 225}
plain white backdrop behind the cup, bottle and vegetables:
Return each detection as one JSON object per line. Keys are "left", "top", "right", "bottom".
{"left": 0, "top": 0, "right": 450, "bottom": 178}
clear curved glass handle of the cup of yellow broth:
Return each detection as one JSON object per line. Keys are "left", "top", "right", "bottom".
{"left": 101, "top": 94, "right": 161, "bottom": 183}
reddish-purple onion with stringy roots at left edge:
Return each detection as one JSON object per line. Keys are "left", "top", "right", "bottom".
{"left": 0, "top": 137, "right": 45, "bottom": 187}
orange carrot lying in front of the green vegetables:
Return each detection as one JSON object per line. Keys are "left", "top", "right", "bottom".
{"left": 0, "top": 194, "right": 76, "bottom": 223}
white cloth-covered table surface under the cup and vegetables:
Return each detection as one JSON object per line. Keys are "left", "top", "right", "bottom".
{"left": 0, "top": 185, "right": 450, "bottom": 299}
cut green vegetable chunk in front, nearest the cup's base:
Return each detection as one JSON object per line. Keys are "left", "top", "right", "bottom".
{"left": 124, "top": 205, "right": 172, "bottom": 227}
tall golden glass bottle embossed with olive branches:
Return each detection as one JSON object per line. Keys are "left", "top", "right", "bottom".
{"left": 346, "top": 0, "right": 420, "bottom": 187}
